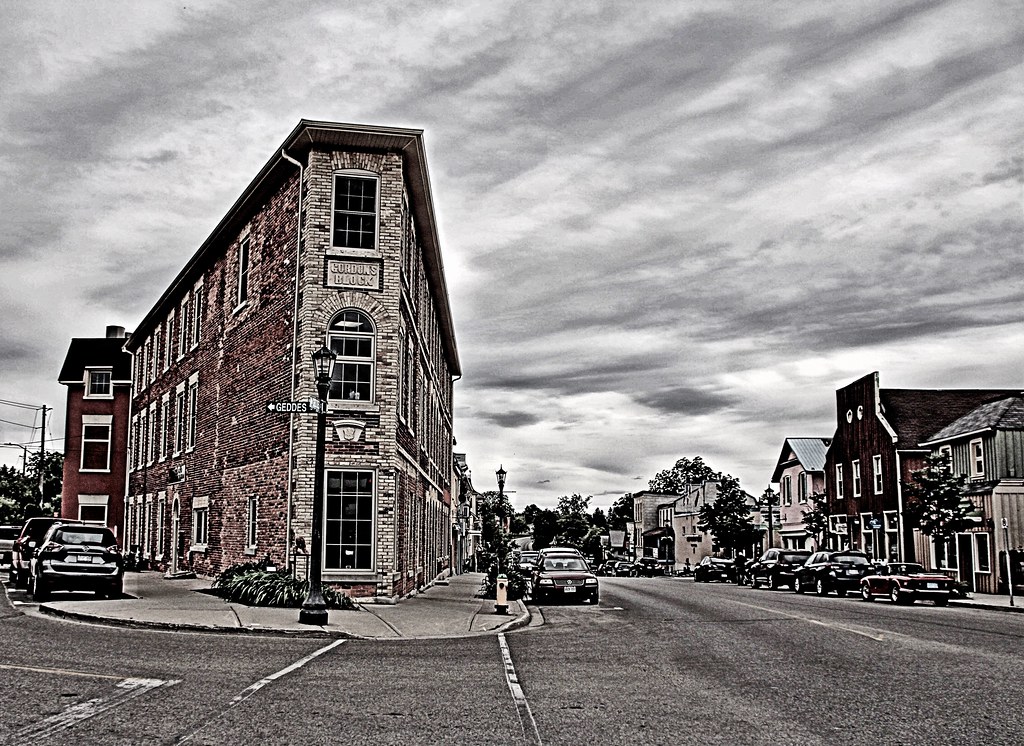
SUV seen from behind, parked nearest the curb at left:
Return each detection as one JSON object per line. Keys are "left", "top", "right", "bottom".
{"left": 29, "top": 523, "right": 124, "bottom": 601}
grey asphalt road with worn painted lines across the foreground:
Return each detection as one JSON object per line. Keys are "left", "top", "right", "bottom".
{"left": 0, "top": 578, "right": 1024, "bottom": 746}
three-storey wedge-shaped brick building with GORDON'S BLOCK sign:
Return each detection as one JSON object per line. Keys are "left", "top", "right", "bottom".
{"left": 126, "top": 120, "right": 461, "bottom": 600}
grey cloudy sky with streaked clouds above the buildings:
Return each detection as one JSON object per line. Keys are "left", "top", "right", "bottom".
{"left": 0, "top": 0, "right": 1024, "bottom": 507}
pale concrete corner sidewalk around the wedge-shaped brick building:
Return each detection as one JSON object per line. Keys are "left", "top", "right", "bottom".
{"left": 28, "top": 572, "right": 530, "bottom": 640}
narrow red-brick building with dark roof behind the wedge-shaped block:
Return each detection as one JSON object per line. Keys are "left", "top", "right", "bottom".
{"left": 57, "top": 326, "right": 131, "bottom": 536}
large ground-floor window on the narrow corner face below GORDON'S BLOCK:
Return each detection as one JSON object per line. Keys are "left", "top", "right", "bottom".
{"left": 324, "top": 472, "right": 374, "bottom": 570}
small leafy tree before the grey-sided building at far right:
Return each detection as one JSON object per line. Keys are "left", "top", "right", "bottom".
{"left": 903, "top": 453, "right": 976, "bottom": 543}
